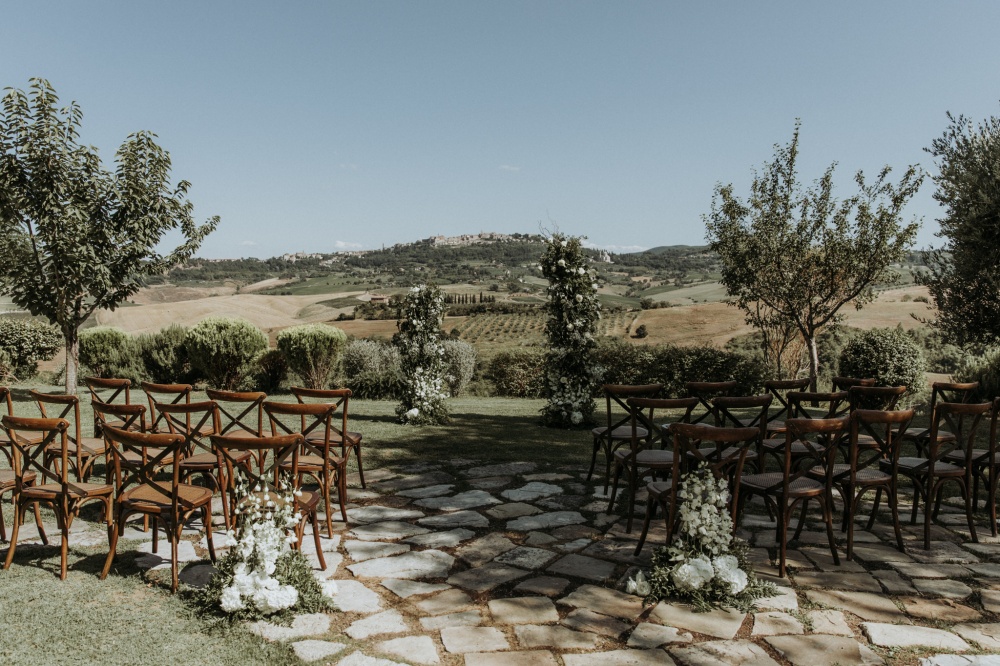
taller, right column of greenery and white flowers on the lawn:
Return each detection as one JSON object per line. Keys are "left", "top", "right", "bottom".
{"left": 540, "top": 234, "right": 602, "bottom": 428}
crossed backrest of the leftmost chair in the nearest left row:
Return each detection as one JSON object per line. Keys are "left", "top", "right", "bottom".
{"left": 0, "top": 415, "right": 72, "bottom": 493}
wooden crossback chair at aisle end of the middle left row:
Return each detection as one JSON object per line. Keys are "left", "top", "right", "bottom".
{"left": 264, "top": 401, "right": 347, "bottom": 537}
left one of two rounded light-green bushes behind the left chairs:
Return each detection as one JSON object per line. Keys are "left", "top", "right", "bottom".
{"left": 184, "top": 317, "right": 267, "bottom": 391}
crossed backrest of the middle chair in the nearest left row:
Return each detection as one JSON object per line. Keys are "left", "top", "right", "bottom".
{"left": 104, "top": 425, "right": 192, "bottom": 508}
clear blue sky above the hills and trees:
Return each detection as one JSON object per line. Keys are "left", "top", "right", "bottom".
{"left": 0, "top": 0, "right": 1000, "bottom": 257}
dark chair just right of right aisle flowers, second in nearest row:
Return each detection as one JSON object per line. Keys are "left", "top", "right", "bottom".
{"left": 740, "top": 418, "right": 847, "bottom": 578}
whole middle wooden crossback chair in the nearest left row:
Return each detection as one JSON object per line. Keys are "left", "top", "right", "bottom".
{"left": 101, "top": 426, "right": 215, "bottom": 592}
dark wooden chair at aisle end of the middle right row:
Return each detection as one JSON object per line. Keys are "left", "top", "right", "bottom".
{"left": 608, "top": 398, "right": 698, "bottom": 533}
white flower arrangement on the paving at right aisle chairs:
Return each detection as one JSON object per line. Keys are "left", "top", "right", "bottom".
{"left": 628, "top": 467, "right": 777, "bottom": 612}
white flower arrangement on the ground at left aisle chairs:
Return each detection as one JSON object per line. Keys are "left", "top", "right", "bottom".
{"left": 197, "top": 474, "right": 337, "bottom": 620}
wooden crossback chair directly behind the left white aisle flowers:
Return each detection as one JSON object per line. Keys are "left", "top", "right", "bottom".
{"left": 212, "top": 433, "right": 326, "bottom": 571}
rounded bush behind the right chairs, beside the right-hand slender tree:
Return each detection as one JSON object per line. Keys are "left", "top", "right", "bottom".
{"left": 838, "top": 328, "right": 926, "bottom": 397}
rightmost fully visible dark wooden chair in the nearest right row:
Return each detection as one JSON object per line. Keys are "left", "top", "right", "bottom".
{"left": 896, "top": 402, "right": 992, "bottom": 550}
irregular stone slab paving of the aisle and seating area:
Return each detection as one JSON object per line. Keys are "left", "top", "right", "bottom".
{"left": 23, "top": 460, "right": 1000, "bottom": 666}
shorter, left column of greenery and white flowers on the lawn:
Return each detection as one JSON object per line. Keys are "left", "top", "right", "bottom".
{"left": 395, "top": 285, "right": 448, "bottom": 425}
